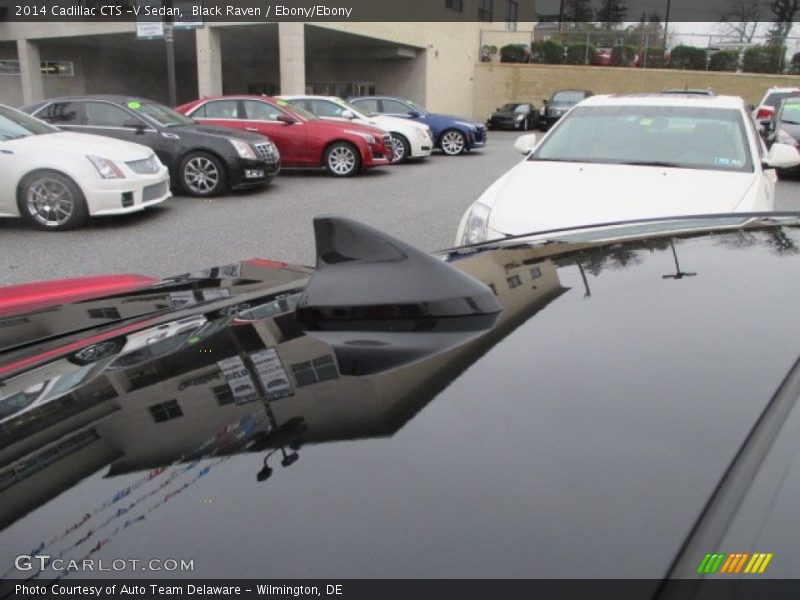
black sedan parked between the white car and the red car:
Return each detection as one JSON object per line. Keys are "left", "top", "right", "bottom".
{"left": 22, "top": 95, "right": 280, "bottom": 196}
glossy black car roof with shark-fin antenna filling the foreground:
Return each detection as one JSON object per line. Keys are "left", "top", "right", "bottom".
{"left": 0, "top": 213, "right": 800, "bottom": 598}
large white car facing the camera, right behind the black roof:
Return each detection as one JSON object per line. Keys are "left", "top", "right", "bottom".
{"left": 456, "top": 94, "right": 800, "bottom": 245}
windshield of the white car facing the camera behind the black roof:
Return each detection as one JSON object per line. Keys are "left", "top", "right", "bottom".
{"left": 528, "top": 105, "right": 753, "bottom": 171}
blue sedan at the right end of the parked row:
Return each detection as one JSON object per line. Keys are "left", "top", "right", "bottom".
{"left": 349, "top": 96, "right": 486, "bottom": 156}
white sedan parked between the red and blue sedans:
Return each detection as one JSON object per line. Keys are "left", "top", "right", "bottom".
{"left": 281, "top": 96, "right": 435, "bottom": 163}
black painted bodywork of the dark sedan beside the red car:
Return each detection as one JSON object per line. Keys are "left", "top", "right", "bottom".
{"left": 21, "top": 95, "right": 280, "bottom": 189}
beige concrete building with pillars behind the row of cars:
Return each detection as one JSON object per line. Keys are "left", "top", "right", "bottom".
{"left": 0, "top": 0, "right": 534, "bottom": 115}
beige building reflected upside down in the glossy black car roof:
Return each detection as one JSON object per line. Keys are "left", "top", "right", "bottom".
{"left": 0, "top": 246, "right": 565, "bottom": 526}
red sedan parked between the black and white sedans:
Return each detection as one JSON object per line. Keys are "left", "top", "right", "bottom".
{"left": 178, "top": 96, "right": 392, "bottom": 177}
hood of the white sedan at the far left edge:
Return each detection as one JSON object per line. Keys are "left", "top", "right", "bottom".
{"left": 12, "top": 131, "right": 153, "bottom": 162}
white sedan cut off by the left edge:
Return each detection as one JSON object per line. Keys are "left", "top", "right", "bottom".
{"left": 0, "top": 105, "right": 172, "bottom": 231}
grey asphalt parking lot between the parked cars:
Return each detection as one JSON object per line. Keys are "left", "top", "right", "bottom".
{"left": 0, "top": 132, "right": 800, "bottom": 285}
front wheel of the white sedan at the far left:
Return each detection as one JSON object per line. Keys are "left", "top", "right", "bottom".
{"left": 17, "top": 171, "right": 89, "bottom": 231}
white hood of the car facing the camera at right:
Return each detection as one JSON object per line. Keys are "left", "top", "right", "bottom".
{"left": 488, "top": 161, "right": 756, "bottom": 235}
